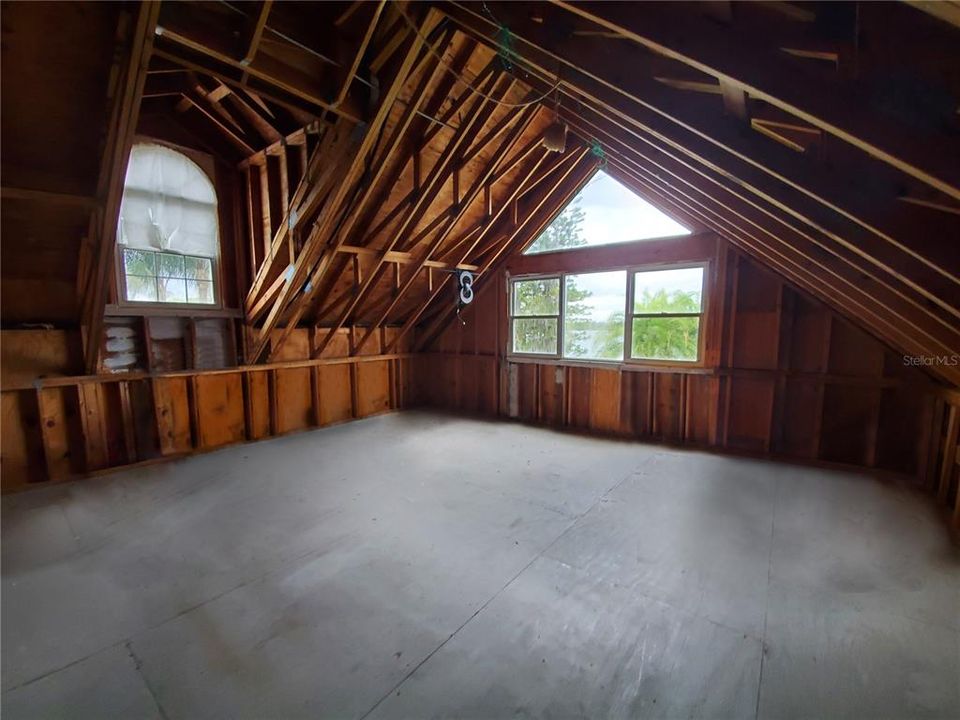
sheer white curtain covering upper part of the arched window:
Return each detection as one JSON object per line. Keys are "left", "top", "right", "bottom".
{"left": 118, "top": 145, "right": 219, "bottom": 258}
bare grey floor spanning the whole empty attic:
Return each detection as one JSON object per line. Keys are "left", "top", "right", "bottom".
{"left": 2, "top": 413, "right": 960, "bottom": 720}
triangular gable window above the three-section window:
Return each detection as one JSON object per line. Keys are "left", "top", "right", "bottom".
{"left": 523, "top": 170, "right": 690, "bottom": 255}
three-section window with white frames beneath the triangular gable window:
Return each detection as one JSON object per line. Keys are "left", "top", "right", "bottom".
{"left": 510, "top": 264, "right": 705, "bottom": 364}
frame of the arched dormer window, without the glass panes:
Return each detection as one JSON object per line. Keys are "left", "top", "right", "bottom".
{"left": 115, "top": 139, "right": 223, "bottom": 311}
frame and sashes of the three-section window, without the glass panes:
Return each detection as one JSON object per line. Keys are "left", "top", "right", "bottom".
{"left": 507, "top": 260, "right": 710, "bottom": 367}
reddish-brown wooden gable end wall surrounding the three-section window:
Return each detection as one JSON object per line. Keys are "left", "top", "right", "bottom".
{"left": 417, "top": 235, "right": 952, "bottom": 484}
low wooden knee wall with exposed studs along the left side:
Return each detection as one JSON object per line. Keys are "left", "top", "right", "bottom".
{"left": 0, "top": 336, "right": 412, "bottom": 492}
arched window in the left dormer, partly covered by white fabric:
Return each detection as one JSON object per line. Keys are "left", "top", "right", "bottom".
{"left": 117, "top": 144, "right": 220, "bottom": 305}
